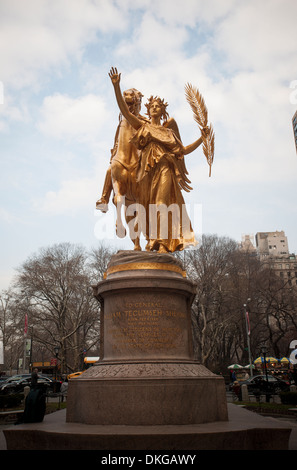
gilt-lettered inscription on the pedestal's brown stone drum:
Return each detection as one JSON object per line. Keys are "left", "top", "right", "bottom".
{"left": 104, "top": 298, "right": 188, "bottom": 359}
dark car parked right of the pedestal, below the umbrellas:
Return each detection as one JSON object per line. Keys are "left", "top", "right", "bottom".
{"left": 241, "top": 375, "right": 290, "bottom": 395}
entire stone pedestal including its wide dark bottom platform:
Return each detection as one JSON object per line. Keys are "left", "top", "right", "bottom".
{"left": 4, "top": 252, "right": 291, "bottom": 452}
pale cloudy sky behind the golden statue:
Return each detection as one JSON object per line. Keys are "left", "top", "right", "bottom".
{"left": 0, "top": 0, "right": 297, "bottom": 290}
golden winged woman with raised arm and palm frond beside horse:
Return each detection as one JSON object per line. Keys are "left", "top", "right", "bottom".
{"left": 96, "top": 68, "right": 214, "bottom": 253}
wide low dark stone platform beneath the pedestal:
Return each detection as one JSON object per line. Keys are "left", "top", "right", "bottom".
{"left": 0, "top": 404, "right": 297, "bottom": 451}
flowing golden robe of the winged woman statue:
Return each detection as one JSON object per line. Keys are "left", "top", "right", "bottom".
{"left": 131, "top": 123, "right": 197, "bottom": 252}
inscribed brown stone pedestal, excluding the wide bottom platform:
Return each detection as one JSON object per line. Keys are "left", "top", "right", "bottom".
{"left": 66, "top": 251, "right": 228, "bottom": 426}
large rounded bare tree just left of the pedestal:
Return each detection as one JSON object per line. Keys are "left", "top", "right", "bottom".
{"left": 16, "top": 243, "right": 99, "bottom": 371}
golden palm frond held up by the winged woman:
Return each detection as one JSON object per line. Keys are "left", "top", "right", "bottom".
{"left": 185, "top": 83, "right": 214, "bottom": 176}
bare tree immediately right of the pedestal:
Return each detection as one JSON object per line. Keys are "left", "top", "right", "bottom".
{"left": 186, "top": 235, "right": 237, "bottom": 365}
